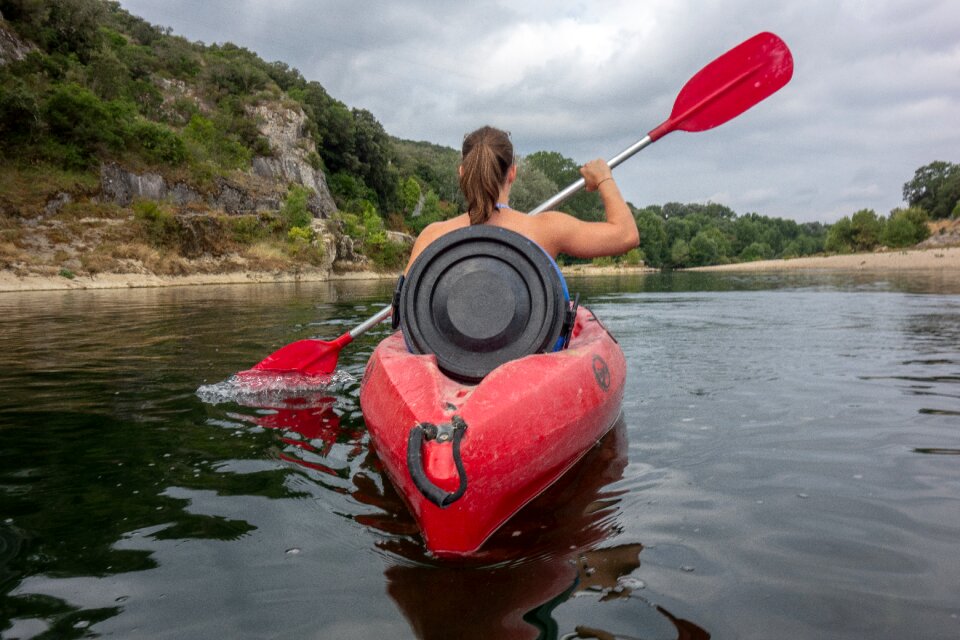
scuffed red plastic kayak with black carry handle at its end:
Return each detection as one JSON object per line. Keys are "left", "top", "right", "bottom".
{"left": 360, "top": 307, "right": 626, "bottom": 557}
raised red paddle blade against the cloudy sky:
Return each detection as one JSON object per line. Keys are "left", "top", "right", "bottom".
{"left": 649, "top": 32, "right": 793, "bottom": 140}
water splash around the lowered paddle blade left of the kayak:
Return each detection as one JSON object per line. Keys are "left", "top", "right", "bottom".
{"left": 197, "top": 369, "right": 356, "bottom": 408}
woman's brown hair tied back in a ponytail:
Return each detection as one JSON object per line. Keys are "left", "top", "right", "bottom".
{"left": 460, "top": 127, "right": 513, "bottom": 224}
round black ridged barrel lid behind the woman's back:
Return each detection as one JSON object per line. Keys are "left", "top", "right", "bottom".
{"left": 400, "top": 225, "right": 566, "bottom": 382}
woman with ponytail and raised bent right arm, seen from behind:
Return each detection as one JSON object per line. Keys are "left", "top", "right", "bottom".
{"left": 407, "top": 127, "right": 640, "bottom": 271}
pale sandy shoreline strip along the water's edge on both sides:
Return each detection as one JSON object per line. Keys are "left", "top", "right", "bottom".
{"left": 0, "top": 247, "right": 960, "bottom": 293}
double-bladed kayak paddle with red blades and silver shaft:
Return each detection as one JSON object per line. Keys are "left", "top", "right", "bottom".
{"left": 241, "top": 33, "right": 793, "bottom": 376}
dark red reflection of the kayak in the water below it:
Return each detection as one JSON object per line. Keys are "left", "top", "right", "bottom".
{"left": 379, "top": 420, "right": 710, "bottom": 640}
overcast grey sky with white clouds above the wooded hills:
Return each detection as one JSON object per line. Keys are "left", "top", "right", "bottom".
{"left": 120, "top": 0, "right": 960, "bottom": 222}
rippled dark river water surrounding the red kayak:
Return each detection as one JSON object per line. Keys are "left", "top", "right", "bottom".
{"left": 0, "top": 272, "right": 960, "bottom": 639}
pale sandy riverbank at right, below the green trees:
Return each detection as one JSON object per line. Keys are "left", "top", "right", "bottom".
{"left": 690, "top": 247, "right": 960, "bottom": 272}
